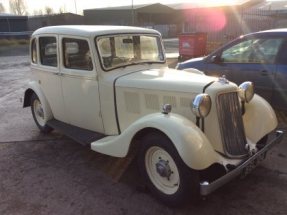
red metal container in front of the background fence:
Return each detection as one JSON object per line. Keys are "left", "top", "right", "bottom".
{"left": 178, "top": 33, "right": 207, "bottom": 60}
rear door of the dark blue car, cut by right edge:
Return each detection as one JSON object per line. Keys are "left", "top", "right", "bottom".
{"left": 272, "top": 40, "right": 287, "bottom": 110}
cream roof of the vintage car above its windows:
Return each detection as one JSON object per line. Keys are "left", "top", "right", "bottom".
{"left": 32, "top": 25, "right": 160, "bottom": 37}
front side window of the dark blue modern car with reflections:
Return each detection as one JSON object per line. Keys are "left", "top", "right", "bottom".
{"left": 222, "top": 38, "right": 283, "bottom": 64}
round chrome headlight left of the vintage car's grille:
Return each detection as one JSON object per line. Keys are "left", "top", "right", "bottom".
{"left": 192, "top": 93, "right": 211, "bottom": 118}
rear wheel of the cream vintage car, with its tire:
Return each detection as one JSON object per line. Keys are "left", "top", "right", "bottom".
{"left": 31, "top": 93, "right": 53, "bottom": 134}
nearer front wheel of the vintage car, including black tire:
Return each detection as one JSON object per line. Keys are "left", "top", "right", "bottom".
{"left": 138, "top": 133, "right": 199, "bottom": 207}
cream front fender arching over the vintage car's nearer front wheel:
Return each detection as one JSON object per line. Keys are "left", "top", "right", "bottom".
{"left": 91, "top": 113, "right": 220, "bottom": 170}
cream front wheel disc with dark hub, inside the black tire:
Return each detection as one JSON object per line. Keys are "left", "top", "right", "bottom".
{"left": 145, "top": 146, "right": 180, "bottom": 195}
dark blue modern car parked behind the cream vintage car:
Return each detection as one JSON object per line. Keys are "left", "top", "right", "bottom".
{"left": 177, "top": 28, "right": 287, "bottom": 110}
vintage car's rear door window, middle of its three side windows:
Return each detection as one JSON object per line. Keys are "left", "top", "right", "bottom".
{"left": 39, "top": 37, "right": 58, "bottom": 67}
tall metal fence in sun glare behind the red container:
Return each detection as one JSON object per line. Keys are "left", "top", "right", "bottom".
{"left": 148, "top": 9, "right": 287, "bottom": 53}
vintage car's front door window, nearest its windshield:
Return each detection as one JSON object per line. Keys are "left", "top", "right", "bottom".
{"left": 62, "top": 38, "right": 93, "bottom": 71}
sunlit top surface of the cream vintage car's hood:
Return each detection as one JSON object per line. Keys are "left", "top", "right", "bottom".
{"left": 116, "top": 68, "right": 217, "bottom": 93}
